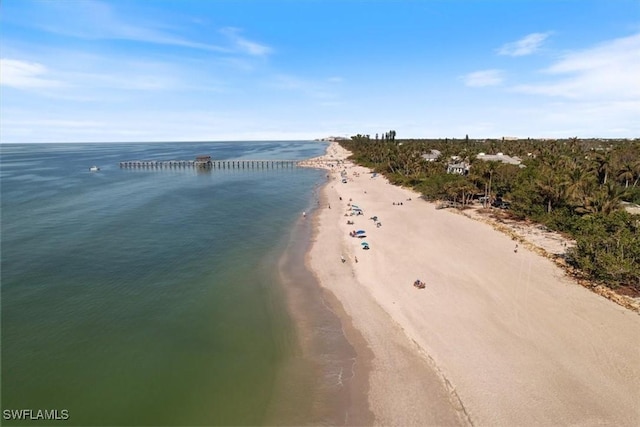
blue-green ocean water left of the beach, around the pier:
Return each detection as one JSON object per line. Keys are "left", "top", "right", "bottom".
{"left": 0, "top": 141, "right": 326, "bottom": 426}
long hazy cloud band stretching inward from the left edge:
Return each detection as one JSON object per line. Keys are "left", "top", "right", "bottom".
{"left": 0, "top": 50, "right": 226, "bottom": 102}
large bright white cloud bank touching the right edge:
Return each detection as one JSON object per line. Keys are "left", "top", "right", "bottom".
{"left": 513, "top": 33, "right": 640, "bottom": 99}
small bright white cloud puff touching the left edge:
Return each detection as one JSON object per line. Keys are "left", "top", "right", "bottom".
{"left": 0, "top": 58, "right": 63, "bottom": 89}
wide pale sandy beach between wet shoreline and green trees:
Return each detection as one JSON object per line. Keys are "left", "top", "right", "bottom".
{"left": 306, "top": 143, "right": 640, "bottom": 426}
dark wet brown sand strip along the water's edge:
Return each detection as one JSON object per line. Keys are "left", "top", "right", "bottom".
{"left": 265, "top": 192, "right": 373, "bottom": 426}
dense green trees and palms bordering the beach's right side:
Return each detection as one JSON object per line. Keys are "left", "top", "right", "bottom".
{"left": 341, "top": 135, "right": 640, "bottom": 292}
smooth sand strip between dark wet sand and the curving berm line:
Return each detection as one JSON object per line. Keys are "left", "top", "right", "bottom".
{"left": 306, "top": 144, "right": 471, "bottom": 426}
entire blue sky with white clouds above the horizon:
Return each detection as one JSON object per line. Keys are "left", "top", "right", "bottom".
{"left": 0, "top": 0, "right": 640, "bottom": 142}
